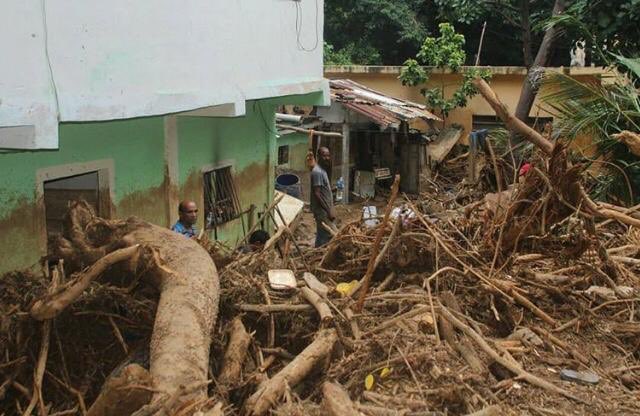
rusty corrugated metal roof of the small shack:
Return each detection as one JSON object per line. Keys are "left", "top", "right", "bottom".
{"left": 329, "top": 79, "right": 442, "bottom": 128}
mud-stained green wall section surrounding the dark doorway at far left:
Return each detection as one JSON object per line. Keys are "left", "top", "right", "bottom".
{"left": 0, "top": 117, "right": 165, "bottom": 273}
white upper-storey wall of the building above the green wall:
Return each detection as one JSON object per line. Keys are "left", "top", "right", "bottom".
{"left": 0, "top": 0, "right": 328, "bottom": 148}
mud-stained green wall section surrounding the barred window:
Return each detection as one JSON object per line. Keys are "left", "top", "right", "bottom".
{"left": 178, "top": 101, "right": 277, "bottom": 244}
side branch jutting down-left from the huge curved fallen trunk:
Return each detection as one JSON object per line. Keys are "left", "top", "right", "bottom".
{"left": 31, "top": 244, "right": 140, "bottom": 321}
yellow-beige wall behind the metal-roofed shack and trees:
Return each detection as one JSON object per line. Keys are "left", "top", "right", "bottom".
{"left": 324, "top": 66, "right": 603, "bottom": 153}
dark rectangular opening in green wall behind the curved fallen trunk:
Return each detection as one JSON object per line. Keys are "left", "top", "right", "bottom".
{"left": 44, "top": 171, "right": 103, "bottom": 238}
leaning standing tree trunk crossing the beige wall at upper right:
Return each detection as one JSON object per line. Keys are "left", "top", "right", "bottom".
{"left": 511, "top": 0, "right": 565, "bottom": 146}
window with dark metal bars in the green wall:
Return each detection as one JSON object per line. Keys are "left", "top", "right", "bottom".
{"left": 204, "top": 166, "right": 241, "bottom": 228}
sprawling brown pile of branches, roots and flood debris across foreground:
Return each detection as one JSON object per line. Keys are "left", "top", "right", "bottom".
{"left": 0, "top": 79, "right": 640, "bottom": 416}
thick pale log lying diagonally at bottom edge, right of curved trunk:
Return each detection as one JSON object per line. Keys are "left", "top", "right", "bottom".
{"left": 245, "top": 328, "right": 338, "bottom": 416}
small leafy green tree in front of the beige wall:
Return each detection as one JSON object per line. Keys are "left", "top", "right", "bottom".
{"left": 399, "top": 23, "right": 490, "bottom": 117}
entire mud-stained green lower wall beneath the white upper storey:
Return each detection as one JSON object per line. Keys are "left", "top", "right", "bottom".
{"left": 0, "top": 93, "right": 323, "bottom": 273}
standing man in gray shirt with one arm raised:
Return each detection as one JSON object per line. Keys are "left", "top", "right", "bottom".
{"left": 311, "top": 147, "right": 336, "bottom": 247}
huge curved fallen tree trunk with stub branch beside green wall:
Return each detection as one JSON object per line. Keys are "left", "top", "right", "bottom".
{"left": 41, "top": 202, "right": 219, "bottom": 410}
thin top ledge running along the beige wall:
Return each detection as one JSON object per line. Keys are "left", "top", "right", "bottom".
{"left": 324, "top": 65, "right": 607, "bottom": 75}
